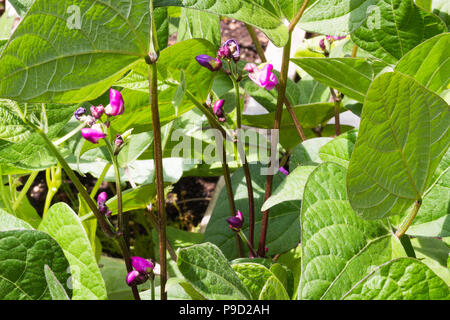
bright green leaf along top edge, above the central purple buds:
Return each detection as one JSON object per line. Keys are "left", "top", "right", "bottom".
{"left": 154, "top": 0, "right": 288, "bottom": 47}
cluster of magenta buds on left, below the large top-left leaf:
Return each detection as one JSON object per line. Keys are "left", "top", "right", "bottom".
{"left": 74, "top": 89, "right": 125, "bottom": 144}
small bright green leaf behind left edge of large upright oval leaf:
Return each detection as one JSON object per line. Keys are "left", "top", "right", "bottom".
{"left": 319, "top": 129, "right": 358, "bottom": 168}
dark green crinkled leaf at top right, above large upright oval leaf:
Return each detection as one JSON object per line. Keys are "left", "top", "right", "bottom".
{"left": 351, "top": 0, "right": 447, "bottom": 63}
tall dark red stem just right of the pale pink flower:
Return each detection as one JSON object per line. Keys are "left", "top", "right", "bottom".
{"left": 258, "top": 34, "right": 292, "bottom": 257}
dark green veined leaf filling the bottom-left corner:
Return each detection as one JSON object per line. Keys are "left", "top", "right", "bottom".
{"left": 0, "top": 230, "right": 71, "bottom": 300}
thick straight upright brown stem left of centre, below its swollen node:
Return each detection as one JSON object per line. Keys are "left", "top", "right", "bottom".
{"left": 148, "top": 61, "right": 167, "bottom": 300}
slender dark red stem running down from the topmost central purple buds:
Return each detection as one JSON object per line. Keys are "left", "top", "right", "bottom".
{"left": 230, "top": 76, "right": 255, "bottom": 252}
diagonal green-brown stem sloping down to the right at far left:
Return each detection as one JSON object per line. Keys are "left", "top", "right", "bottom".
{"left": 27, "top": 121, "right": 116, "bottom": 237}
